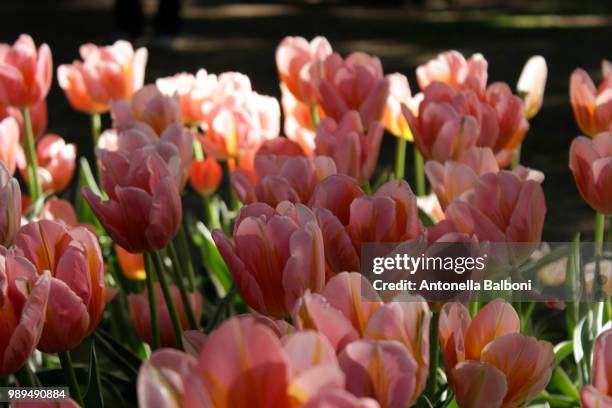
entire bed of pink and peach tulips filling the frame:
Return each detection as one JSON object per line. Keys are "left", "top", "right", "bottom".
{"left": 0, "top": 35, "right": 612, "bottom": 408}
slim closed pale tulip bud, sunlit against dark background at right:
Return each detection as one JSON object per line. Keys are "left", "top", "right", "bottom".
{"left": 516, "top": 55, "right": 548, "bottom": 119}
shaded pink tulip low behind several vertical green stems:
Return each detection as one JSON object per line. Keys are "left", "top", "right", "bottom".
{"left": 128, "top": 283, "right": 202, "bottom": 347}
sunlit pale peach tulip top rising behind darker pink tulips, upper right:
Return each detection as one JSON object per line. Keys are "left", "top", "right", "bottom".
{"left": 416, "top": 50, "right": 488, "bottom": 93}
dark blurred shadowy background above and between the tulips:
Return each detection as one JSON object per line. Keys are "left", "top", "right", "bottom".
{"left": 0, "top": 0, "right": 612, "bottom": 241}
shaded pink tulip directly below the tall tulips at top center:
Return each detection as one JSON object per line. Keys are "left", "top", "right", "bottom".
{"left": 315, "top": 111, "right": 384, "bottom": 182}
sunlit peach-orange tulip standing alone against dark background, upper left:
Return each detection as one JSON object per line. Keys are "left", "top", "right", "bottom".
{"left": 57, "top": 41, "right": 147, "bottom": 113}
